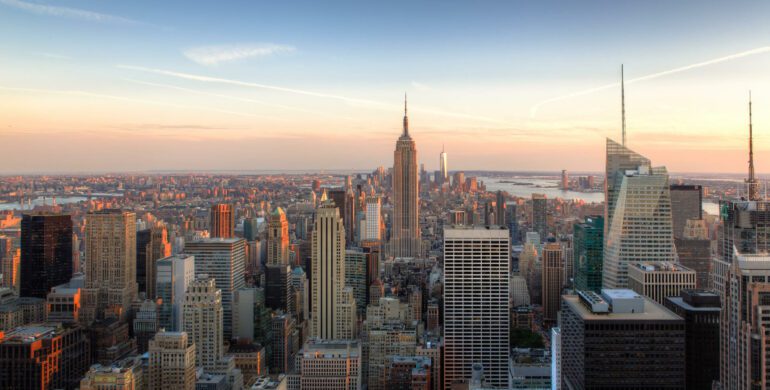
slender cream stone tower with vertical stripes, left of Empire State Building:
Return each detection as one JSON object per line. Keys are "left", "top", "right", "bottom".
{"left": 310, "top": 201, "right": 356, "bottom": 340}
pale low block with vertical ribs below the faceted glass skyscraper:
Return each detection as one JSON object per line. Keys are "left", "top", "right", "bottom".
{"left": 628, "top": 261, "right": 695, "bottom": 305}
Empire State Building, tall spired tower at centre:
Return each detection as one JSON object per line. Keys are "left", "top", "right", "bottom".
{"left": 390, "top": 98, "right": 421, "bottom": 257}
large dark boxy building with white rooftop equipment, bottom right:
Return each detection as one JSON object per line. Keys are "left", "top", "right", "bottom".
{"left": 559, "top": 289, "right": 685, "bottom": 389}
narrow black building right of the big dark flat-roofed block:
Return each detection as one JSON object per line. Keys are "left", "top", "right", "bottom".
{"left": 665, "top": 290, "right": 721, "bottom": 389}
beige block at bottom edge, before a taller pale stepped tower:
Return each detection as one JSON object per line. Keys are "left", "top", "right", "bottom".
{"left": 146, "top": 331, "right": 195, "bottom": 390}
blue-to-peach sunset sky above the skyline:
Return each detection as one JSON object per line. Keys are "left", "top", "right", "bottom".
{"left": 0, "top": 0, "right": 770, "bottom": 174}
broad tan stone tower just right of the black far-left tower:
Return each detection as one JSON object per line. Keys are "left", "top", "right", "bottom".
{"left": 80, "top": 209, "right": 138, "bottom": 323}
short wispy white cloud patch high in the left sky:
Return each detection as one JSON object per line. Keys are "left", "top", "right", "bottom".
{"left": 183, "top": 43, "right": 296, "bottom": 66}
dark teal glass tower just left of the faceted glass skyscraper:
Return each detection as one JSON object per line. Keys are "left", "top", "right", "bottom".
{"left": 573, "top": 216, "right": 604, "bottom": 293}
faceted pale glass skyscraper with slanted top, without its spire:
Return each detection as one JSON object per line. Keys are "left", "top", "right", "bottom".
{"left": 603, "top": 138, "right": 677, "bottom": 288}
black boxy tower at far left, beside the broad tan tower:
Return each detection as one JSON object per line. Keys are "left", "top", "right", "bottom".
{"left": 19, "top": 213, "right": 72, "bottom": 298}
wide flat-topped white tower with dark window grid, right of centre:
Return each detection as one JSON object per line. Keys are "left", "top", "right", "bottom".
{"left": 444, "top": 226, "right": 511, "bottom": 389}
